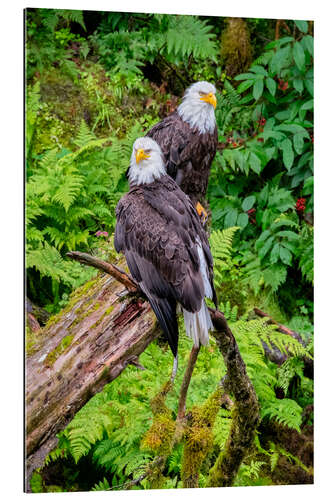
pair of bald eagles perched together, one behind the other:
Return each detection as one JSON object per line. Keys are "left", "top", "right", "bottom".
{"left": 114, "top": 82, "right": 217, "bottom": 357}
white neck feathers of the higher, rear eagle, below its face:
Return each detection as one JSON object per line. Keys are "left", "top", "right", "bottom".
{"left": 178, "top": 97, "right": 216, "bottom": 134}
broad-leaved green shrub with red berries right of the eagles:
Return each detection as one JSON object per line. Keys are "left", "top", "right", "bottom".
{"left": 209, "top": 24, "right": 313, "bottom": 300}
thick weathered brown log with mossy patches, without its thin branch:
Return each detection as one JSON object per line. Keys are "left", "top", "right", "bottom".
{"left": 25, "top": 268, "right": 160, "bottom": 490}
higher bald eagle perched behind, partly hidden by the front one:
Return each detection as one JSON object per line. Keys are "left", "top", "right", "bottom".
{"left": 147, "top": 82, "right": 217, "bottom": 220}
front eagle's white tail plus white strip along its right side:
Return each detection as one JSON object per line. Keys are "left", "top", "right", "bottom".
{"left": 183, "top": 239, "right": 213, "bottom": 347}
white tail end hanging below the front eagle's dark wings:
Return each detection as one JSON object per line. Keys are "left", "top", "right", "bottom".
{"left": 183, "top": 300, "right": 213, "bottom": 347}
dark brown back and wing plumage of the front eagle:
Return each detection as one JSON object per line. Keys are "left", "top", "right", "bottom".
{"left": 114, "top": 176, "right": 217, "bottom": 355}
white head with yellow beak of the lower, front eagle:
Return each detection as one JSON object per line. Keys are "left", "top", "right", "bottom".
{"left": 128, "top": 137, "right": 166, "bottom": 186}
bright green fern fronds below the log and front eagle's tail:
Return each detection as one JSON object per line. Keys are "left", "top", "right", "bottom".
{"left": 39, "top": 306, "right": 309, "bottom": 490}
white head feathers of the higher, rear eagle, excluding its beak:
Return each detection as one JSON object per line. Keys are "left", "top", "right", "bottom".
{"left": 178, "top": 82, "right": 216, "bottom": 134}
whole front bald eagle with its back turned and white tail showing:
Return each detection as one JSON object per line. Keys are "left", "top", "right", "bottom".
{"left": 114, "top": 137, "right": 216, "bottom": 357}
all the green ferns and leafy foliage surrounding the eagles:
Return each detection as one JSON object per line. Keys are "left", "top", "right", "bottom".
{"left": 26, "top": 9, "right": 313, "bottom": 492}
